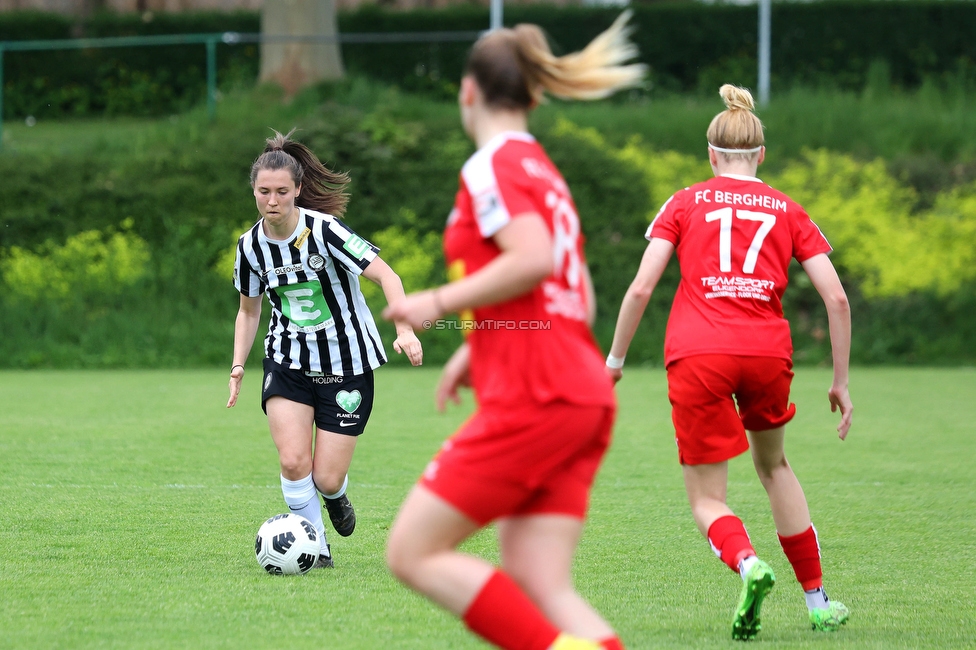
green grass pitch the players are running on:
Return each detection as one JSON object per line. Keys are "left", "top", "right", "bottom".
{"left": 0, "top": 364, "right": 976, "bottom": 650}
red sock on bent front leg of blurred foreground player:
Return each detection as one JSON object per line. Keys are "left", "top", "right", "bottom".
{"left": 464, "top": 571, "right": 559, "bottom": 650}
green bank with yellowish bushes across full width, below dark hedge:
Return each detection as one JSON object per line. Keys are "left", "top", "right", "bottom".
{"left": 0, "top": 78, "right": 976, "bottom": 367}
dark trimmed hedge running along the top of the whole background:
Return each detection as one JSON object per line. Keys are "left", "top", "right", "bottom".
{"left": 0, "top": 0, "right": 976, "bottom": 118}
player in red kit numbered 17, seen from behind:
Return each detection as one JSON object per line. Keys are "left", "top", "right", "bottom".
{"left": 606, "top": 85, "right": 853, "bottom": 639}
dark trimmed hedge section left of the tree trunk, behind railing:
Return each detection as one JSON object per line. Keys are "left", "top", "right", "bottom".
{"left": 0, "top": 12, "right": 259, "bottom": 119}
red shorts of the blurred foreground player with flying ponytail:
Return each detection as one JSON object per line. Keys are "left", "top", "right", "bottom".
{"left": 420, "top": 402, "right": 616, "bottom": 525}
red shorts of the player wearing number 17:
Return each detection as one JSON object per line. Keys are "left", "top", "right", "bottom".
{"left": 668, "top": 354, "right": 796, "bottom": 465}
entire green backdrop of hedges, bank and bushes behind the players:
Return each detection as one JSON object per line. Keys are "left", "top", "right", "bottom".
{"left": 0, "top": 2, "right": 976, "bottom": 367}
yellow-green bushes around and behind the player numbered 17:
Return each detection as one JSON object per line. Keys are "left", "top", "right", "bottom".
{"left": 543, "top": 121, "right": 976, "bottom": 363}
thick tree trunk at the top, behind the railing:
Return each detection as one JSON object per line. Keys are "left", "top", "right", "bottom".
{"left": 260, "top": 0, "right": 343, "bottom": 97}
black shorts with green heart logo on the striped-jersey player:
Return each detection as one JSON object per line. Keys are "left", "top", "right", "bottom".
{"left": 261, "top": 358, "right": 373, "bottom": 436}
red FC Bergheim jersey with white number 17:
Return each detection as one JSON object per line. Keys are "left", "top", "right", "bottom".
{"left": 646, "top": 174, "right": 831, "bottom": 365}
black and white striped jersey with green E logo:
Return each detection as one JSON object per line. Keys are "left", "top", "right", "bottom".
{"left": 234, "top": 208, "right": 386, "bottom": 376}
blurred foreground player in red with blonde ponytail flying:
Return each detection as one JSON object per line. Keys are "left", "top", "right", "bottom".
{"left": 384, "top": 16, "right": 644, "bottom": 650}
